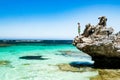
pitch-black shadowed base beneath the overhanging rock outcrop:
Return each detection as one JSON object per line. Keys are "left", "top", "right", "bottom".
{"left": 92, "top": 57, "right": 120, "bottom": 69}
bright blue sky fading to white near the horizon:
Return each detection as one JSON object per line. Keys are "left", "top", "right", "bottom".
{"left": 0, "top": 0, "right": 120, "bottom": 40}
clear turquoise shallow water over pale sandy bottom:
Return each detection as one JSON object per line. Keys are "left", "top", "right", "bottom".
{"left": 0, "top": 43, "right": 97, "bottom": 80}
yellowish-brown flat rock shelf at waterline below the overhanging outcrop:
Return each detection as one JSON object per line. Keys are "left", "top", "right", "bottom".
{"left": 57, "top": 64, "right": 120, "bottom": 80}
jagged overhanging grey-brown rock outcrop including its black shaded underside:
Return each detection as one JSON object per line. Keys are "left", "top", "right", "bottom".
{"left": 73, "top": 16, "right": 120, "bottom": 68}
